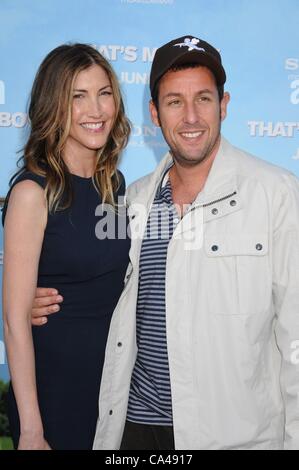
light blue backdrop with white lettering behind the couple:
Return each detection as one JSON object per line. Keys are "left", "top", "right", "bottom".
{"left": 0, "top": 0, "right": 299, "bottom": 379}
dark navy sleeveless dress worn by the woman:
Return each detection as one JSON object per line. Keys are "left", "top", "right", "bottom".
{"left": 3, "top": 172, "right": 130, "bottom": 450}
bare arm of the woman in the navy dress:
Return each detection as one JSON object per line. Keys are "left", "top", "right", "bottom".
{"left": 3, "top": 180, "right": 48, "bottom": 449}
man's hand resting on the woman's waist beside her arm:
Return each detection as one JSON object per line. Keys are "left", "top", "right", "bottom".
{"left": 31, "top": 287, "right": 63, "bottom": 326}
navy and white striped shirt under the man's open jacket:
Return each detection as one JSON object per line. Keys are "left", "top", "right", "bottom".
{"left": 127, "top": 168, "right": 179, "bottom": 425}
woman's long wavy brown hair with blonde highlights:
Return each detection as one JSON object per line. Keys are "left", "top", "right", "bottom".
{"left": 13, "top": 44, "right": 130, "bottom": 212}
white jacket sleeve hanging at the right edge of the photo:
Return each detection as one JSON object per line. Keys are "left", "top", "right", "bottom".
{"left": 273, "top": 175, "right": 299, "bottom": 450}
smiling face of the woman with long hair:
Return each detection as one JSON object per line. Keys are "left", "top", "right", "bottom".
{"left": 66, "top": 65, "right": 116, "bottom": 156}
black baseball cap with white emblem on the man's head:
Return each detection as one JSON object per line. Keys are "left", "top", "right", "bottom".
{"left": 150, "top": 35, "right": 226, "bottom": 96}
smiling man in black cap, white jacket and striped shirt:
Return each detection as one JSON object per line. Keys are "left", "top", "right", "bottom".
{"left": 32, "top": 36, "right": 299, "bottom": 450}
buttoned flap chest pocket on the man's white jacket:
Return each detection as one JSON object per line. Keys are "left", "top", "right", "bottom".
{"left": 204, "top": 233, "right": 271, "bottom": 315}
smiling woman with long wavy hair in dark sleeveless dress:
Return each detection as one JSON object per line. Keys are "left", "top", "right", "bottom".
{"left": 3, "top": 44, "right": 130, "bottom": 449}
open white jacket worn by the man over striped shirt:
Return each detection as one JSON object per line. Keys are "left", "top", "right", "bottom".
{"left": 94, "top": 138, "right": 299, "bottom": 450}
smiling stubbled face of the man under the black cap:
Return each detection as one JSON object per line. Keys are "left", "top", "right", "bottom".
{"left": 150, "top": 66, "right": 229, "bottom": 166}
